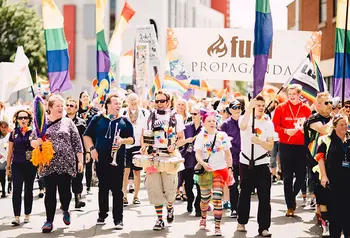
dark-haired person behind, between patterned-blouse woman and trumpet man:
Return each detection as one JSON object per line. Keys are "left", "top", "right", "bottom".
{"left": 78, "top": 91, "right": 98, "bottom": 194}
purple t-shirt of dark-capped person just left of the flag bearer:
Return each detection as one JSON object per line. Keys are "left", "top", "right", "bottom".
{"left": 220, "top": 117, "right": 241, "bottom": 165}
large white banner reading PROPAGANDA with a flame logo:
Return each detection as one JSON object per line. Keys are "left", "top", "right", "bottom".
{"left": 167, "top": 28, "right": 320, "bottom": 83}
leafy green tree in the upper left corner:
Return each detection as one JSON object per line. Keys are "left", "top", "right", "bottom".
{"left": 0, "top": 0, "right": 47, "bottom": 81}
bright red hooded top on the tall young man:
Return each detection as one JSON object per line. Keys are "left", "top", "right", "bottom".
{"left": 272, "top": 101, "right": 311, "bottom": 145}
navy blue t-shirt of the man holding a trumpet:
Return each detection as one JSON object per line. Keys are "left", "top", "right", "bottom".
{"left": 84, "top": 115, "right": 135, "bottom": 164}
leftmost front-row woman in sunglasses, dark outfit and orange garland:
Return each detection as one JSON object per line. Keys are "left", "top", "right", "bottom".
{"left": 6, "top": 110, "right": 36, "bottom": 226}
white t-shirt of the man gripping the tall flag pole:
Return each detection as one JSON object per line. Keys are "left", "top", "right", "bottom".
{"left": 238, "top": 116, "right": 275, "bottom": 165}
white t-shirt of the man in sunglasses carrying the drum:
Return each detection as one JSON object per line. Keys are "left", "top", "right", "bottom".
{"left": 149, "top": 111, "right": 185, "bottom": 148}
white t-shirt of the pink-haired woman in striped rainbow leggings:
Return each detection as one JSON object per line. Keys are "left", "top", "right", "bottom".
{"left": 194, "top": 130, "right": 231, "bottom": 171}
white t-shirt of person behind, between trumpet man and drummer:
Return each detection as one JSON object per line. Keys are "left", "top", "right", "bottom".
{"left": 120, "top": 108, "right": 150, "bottom": 149}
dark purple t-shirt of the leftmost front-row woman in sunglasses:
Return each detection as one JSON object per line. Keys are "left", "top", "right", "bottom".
{"left": 9, "top": 128, "right": 33, "bottom": 163}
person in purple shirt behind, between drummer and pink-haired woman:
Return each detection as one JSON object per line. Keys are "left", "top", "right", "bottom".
{"left": 180, "top": 105, "right": 202, "bottom": 217}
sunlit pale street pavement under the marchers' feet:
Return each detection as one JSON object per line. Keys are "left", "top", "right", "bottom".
{"left": 0, "top": 179, "right": 322, "bottom": 238}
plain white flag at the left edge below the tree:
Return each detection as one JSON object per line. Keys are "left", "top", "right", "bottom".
{"left": 0, "top": 46, "right": 33, "bottom": 102}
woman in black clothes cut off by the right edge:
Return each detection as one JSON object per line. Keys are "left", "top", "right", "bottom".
{"left": 315, "top": 115, "right": 350, "bottom": 237}
